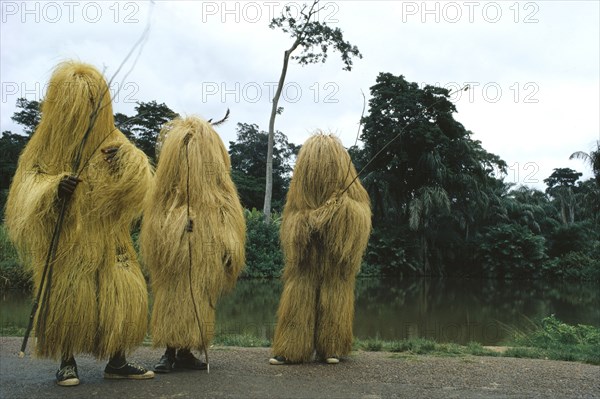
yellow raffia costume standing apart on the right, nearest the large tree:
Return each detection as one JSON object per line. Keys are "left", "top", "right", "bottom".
{"left": 272, "top": 132, "right": 371, "bottom": 364}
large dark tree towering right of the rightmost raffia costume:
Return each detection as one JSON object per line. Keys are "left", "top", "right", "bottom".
{"left": 358, "top": 73, "right": 506, "bottom": 274}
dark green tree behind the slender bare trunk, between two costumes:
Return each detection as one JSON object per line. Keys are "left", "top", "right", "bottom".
{"left": 229, "top": 123, "right": 300, "bottom": 211}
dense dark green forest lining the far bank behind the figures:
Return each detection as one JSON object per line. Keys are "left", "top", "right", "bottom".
{"left": 0, "top": 73, "right": 600, "bottom": 280}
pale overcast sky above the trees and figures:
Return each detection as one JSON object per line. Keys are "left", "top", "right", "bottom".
{"left": 0, "top": 0, "right": 600, "bottom": 189}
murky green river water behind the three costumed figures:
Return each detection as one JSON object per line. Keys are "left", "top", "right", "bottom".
{"left": 0, "top": 279, "right": 600, "bottom": 345}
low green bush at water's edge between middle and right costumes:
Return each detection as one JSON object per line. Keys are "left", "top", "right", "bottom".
{"left": 242, "top": 209, "right": 283, "bottom": 278}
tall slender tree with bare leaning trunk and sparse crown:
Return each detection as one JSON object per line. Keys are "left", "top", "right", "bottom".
{"left": 263, "top": 0, "right": 362, "bottom": 222}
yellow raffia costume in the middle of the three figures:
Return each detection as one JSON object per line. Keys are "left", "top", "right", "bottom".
{"left": 140, "top": 117, "right": 246, "bottom": 350}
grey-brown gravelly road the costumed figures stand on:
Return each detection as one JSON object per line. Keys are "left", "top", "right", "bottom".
{"left": 0, "top": 338, "right": 600, "bottom": 399}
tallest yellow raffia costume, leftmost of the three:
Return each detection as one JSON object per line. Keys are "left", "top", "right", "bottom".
{"left": 5, "top": 62, "right": 151, "bottom": 360}
